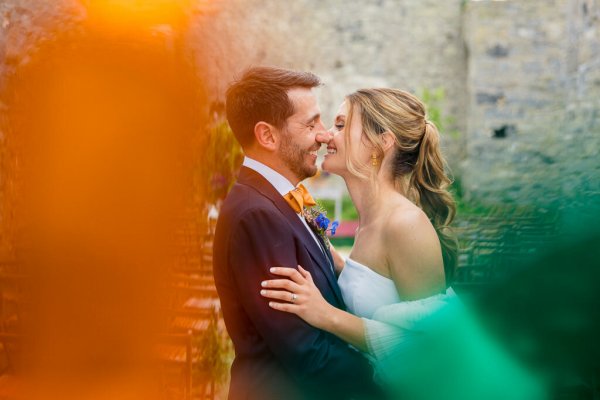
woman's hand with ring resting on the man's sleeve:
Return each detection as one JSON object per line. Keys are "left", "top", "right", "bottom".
{"left": 260, "top": 265, "right": 334, "bottom": 328}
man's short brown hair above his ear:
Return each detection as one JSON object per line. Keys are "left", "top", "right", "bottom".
{"left": 226, "top": 67, "right": 321, "bottom": 147}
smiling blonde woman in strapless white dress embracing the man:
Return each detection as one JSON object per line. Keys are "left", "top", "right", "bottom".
{"left": 261, "top": 88, "right": 544, "bottom": 399}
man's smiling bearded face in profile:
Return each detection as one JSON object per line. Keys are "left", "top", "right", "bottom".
{"left": 279, "top": 88, "right": 325, "bottom": 181}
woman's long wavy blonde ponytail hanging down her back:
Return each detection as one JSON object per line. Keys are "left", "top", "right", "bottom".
{"left": 409, "top": 121, "right": 458, "bottom": 283}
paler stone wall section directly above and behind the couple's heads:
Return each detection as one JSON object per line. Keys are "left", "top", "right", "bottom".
{"left": 190, "top": 0, "right": 467, "bottom": 164}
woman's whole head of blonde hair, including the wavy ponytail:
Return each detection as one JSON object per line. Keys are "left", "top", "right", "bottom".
{"left": 345, "top": 88, "right": 458, "bottom": 283}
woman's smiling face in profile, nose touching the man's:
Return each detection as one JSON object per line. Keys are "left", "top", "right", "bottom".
{"left": 322, "top": 100, "right": 370, "bottom": 176}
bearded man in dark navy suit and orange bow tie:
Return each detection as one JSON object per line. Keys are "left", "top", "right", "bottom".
{"left": 214, "top": 67, "right": 378, "bottom": 400}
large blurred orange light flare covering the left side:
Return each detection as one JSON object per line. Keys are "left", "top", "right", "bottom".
{"left": 0, "top": 17, "right": 205, "bottom": 400}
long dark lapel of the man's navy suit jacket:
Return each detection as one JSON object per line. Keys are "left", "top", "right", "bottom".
{"left": 238, "top": 166, "right": 344, "bottom": 304}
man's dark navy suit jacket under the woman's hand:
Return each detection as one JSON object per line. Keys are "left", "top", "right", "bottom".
{"left": 214, "top": 167, "right": 378, "bottom": 400}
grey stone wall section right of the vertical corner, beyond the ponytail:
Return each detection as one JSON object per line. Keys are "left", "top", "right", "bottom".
{"left": 461, "top": 0, "right": 600, "bottom": 203}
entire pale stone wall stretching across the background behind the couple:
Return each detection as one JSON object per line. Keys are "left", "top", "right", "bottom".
{"left": 0, "top": 0, "right": 600, "bottom": 202}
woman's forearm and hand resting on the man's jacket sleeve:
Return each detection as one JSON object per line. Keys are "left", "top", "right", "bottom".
{"left": 261, "top": 266, "right": 368, "bottom": 352}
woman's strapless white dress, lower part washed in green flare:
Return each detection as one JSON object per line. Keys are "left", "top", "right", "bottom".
{"left": 338, "top": 259, "right": 547, "bottom": 400}
